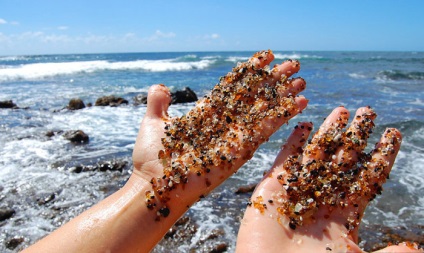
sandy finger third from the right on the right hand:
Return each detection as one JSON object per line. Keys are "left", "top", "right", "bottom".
{"left": 303, "top": 106, "right": 349, "bottom": 163}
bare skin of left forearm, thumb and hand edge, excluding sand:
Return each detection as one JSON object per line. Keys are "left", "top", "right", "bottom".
{"left": 24, "top": 53, "right": 307, "bottom": 252}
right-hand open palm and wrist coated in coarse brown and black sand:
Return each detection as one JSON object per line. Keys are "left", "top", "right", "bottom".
{"left": 237, "top": 107, "right": 420, "bottom": 252}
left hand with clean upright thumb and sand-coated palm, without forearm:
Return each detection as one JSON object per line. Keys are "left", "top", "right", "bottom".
{"left": 133, "top": 51, "right": 307, "bottom": 219}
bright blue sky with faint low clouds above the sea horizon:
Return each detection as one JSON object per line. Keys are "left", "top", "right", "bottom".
{"left": 0, "top": 0, "right": 424, "bottom": 55}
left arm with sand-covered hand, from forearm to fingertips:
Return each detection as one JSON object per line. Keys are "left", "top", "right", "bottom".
{"left": 22, "top": 51, "right": 307, "bottom": 252}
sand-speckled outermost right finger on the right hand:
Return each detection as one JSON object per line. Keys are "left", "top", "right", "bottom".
{"left": 359, "top": 128, "right": 402, "bottom": 201}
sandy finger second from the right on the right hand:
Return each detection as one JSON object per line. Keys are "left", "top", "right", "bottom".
{"left": 333, "top": 107, "right": 377, "bottom": 170}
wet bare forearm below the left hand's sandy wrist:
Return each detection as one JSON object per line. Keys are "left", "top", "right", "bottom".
{"left": 25, "top": 175, "right": 187, "bottom": 252}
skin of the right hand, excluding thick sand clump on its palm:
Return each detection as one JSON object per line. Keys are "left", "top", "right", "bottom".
{"left": 236, "top": 107, "right": 416, "bottom": 252}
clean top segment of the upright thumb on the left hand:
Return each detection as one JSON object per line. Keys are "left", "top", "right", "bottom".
{"left": 146, "top": 84, "right": 171, "bottom": 120}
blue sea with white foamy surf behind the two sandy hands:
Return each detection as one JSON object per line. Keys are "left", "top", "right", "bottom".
{"left": 0, "top": 51, "right": 424, "bottom": 252}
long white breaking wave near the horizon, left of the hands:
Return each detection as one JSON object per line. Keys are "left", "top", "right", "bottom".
{"left": 0, "top": 59, "right": 213, "bottom": 82}
